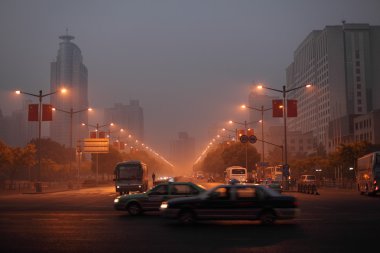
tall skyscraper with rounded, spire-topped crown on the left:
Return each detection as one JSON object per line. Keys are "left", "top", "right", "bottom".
{"left": 50, "top": 32, "right": 88, "bottom": 147}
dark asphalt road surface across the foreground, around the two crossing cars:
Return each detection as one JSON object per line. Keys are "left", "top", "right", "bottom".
{"left": 0, "top": 187, "right": 380, "bottom": 253}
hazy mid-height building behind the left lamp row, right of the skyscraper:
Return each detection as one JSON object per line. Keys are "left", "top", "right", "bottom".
{"left": 104, "top": 100, "right": 144, "bottom": 141}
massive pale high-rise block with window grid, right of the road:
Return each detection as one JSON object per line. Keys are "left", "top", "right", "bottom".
{"left": 286, "top": 22, "right": 380, "bottom": 151}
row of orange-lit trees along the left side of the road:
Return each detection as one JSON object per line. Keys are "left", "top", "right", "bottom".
{"left": 0, "top": 138, "right": 172, "bottom": 183}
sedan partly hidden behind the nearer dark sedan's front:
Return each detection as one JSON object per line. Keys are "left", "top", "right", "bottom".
{"left": 114, "top": 182, "right": 206, "bottom": 215}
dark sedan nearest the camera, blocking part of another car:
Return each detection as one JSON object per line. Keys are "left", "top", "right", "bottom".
{"left": 160, "top": 184, "right": 299, "bottom": 224}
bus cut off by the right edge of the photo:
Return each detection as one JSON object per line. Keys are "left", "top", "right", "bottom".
{"left": 356, "top": 152, "right": 380, "bottom": 194}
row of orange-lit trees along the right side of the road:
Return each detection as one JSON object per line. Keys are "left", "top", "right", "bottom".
{"left": 194, "top": 142, "right": 380, "bottom": 179}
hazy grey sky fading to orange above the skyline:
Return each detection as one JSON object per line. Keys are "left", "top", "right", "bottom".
{"left": 0, "top": 0, "right": 380, "bottom": 158}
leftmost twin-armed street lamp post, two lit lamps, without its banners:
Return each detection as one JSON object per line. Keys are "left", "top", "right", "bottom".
{"left": 16, "top": 89, "right": 66, "bottom": 192}
